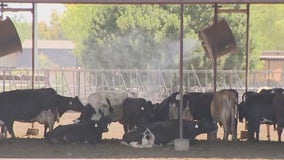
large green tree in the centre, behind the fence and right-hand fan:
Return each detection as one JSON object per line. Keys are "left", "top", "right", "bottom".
{"left": 59, "top": 4, "right": 264, "bottom": 69}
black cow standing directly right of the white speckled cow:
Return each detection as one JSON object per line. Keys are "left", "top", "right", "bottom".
{"left": 119, "top": 98, "right": 155, "bottom": 133}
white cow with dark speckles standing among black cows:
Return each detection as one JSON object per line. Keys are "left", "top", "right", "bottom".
{"left": 87, "top": 91, "right": 138, "bottom": 122}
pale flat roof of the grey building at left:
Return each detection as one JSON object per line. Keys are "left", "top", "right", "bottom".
{"left": 22, "top": 40, "right": 75, "bottom": 49}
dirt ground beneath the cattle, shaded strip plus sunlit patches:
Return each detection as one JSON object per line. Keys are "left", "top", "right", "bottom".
{"left": 0, "top": 112, "right": 284, "bottom": 159}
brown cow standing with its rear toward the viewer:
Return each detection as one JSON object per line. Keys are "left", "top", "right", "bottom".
{"left": 210, "top": 89, "right": 238, "bottom": 141}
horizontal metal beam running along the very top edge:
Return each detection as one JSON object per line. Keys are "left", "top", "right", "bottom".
{"left": 0, "top": 0, "right": 284, "bottom": 4}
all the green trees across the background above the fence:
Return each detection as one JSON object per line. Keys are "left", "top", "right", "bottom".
{"left": 12, "top": 4, "right": 284, "bottom": 70}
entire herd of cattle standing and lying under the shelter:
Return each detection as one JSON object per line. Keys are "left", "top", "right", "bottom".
{"left": 0, "top": 88, "right": 284, "bottom": 148}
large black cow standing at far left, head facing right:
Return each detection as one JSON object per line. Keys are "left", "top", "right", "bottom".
{"left": 0, "top": 88, "right": 83, "bottom": 138}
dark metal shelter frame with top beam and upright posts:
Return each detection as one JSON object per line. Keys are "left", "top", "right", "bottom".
{"left": 0, "top": 0, "right": 284, "bottom": 145}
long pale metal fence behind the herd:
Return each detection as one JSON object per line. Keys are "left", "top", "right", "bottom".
{"left": 0, "top": 68, "right": 284, "bottom": 101}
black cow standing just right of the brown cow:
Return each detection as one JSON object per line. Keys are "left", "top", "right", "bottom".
{"left": 238, "top": 92, "right": 276, "bottom": 141}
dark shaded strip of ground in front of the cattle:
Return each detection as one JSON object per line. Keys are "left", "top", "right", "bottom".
{"left": 0, "top": 138, "right": 284, "bottom": 159}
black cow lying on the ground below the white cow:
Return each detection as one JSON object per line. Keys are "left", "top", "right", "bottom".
{"left": 45, "top": 117, "right": 111, "bottom": 144}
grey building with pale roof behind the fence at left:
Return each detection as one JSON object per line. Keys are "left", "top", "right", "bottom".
{"left": 0, "top": 40, "right": 78, "bottom": 68}
